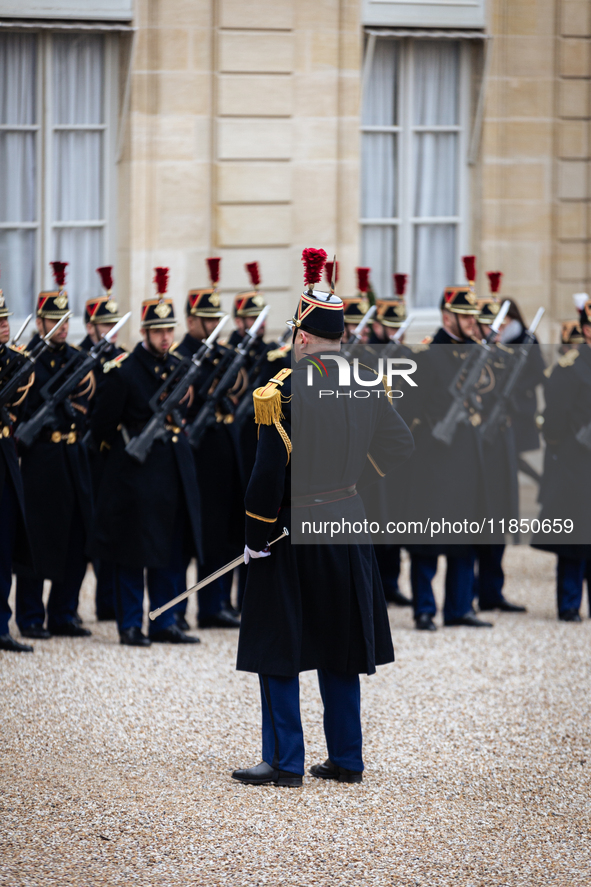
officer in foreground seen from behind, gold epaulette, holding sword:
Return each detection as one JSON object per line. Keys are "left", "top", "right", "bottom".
{"left": 232, "top": 253, "right": 413, "bottom": 786}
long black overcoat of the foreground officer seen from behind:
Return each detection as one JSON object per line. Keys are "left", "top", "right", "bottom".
{"left": 237, "top": 364, "right": 413, "bottom": 676}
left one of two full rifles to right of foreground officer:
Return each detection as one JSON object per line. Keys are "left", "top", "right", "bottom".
{"left": 431, "top": 299, "right": 511, "bottom": 447}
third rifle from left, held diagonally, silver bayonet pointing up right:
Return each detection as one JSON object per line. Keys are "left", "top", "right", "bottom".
{"left": 125, "top": 314, "right": 229, "bottom": 465}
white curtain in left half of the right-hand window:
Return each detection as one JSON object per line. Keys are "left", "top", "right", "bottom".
{"left": 361, "top": 40, "right": 398, "bottom": 298}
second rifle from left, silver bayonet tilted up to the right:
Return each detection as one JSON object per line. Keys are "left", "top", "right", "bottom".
{"left": 15, "top": 311, "right": 131, "bottom": 447}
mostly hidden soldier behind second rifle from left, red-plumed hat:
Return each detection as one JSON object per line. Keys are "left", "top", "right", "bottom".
{"left": 80, "top": 265, "right": 125, "bottom": 622}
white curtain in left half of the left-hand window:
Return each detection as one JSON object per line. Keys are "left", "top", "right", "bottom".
{"left": 0, "top": 34, "right": 37, "bottom": 316}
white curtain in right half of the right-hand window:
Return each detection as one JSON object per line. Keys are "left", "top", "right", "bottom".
{"left": 413, "top": 40, "right": 460, "bottom": 307}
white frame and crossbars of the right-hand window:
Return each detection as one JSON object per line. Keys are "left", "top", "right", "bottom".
{"left": 359, "top": 35, "right": 472, "bottom": 321}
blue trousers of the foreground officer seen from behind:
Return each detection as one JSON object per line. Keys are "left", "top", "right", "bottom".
{"left": 259, "top": 668, "right": 363, "bottom": 774}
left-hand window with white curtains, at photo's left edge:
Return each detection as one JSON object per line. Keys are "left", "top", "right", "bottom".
{"left": 0, "top": 32, "right": 117, "bottom": 317}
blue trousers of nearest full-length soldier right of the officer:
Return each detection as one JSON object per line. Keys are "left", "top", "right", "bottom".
{"left": 410, "top": 552, "right": 475, "bottom": 621}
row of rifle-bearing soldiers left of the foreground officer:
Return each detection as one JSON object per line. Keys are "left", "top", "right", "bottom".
{"left": 0, "top": 259, "right": 289, "bottom": 650}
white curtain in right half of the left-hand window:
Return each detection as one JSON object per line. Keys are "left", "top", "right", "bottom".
{"left": 52, "top": 35, "right": 104, "bottom": 315}
